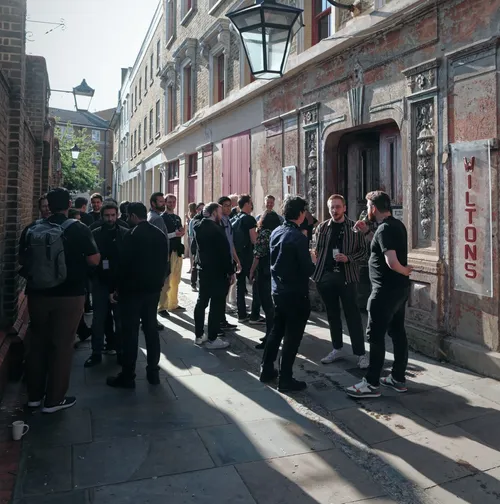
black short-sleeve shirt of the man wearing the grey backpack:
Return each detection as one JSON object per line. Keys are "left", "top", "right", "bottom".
{"left": 19, "top": 214, "right": 99, "bottom": 297}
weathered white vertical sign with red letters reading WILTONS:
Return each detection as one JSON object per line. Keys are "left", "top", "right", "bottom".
{"left": 451, "top": 140, "right": 493, "bottom": 297}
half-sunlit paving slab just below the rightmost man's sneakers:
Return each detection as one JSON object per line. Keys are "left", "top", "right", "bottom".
{"left": 333, "top": 398, "right": 433, "bottom": 445}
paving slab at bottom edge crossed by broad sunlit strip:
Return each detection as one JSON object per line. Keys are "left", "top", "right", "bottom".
{"left": 236, "top": 449, "right": 384, "bottom": 504}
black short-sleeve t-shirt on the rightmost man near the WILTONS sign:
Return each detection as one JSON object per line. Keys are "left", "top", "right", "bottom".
{"left": 368, "top": 215, "right": 410, "bottom": 289}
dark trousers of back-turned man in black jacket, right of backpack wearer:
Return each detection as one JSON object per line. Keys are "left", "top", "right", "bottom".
{"left": 119, "top": 292, "right": 160, "bottom": 379}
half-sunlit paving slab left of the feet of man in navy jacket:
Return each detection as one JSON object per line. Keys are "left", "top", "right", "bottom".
{"left": 168, "top": 371, "right": 265, "bottom": 399}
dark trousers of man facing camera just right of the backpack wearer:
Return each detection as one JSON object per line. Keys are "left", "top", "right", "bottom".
{"left": 92, "top": 279, "right": 121, "bottom": 354}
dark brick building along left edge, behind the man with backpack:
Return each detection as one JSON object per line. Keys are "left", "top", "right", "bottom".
{"left": 0, "top": 0, "right": 57, "bottom": 394}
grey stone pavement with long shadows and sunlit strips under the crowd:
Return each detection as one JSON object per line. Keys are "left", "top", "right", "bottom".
{"left": 5, "top": 261, "right": 500, "bottom": 504}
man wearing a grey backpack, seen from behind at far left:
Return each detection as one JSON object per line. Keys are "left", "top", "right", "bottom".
{"left": 19, "top": 188, "right": 100, "bottom": 413}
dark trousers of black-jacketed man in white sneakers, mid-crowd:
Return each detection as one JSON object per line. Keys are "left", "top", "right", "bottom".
{"left": 194, "top": 270, "right": 228, "bottom": 341}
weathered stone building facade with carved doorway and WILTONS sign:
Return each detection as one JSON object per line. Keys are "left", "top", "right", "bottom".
{"left": 113, "top": 0, "right": 500, "bottom": 377}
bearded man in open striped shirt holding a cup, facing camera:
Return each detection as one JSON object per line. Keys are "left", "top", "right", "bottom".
{"left": 312, "top": 194, "right": 369, "bottom": 369}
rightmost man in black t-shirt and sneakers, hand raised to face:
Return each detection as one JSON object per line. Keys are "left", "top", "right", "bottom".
{"left": 346, "top": 191, "right": 413, "bottom": 398}
